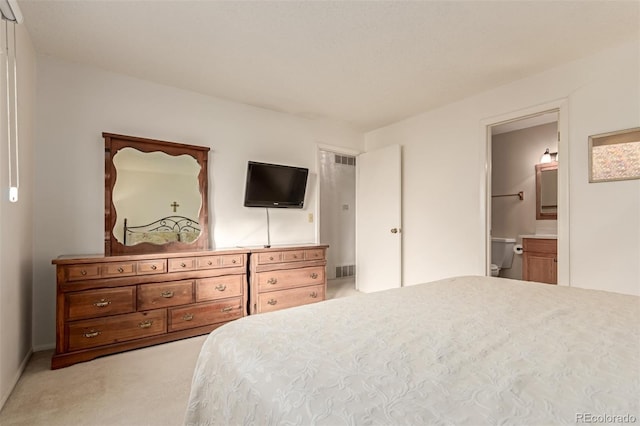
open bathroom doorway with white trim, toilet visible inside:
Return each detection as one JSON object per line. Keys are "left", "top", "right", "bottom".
{"left": 485, "top": 103, "right": 569, "bottom": 285}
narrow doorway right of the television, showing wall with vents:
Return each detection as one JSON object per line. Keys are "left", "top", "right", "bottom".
{"left": 318, "top": 147, "right": 357, "bottom": 298}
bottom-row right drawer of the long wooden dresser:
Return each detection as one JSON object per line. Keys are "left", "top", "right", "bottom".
{"left": 169, "top": 297, "right": 244, "bottom": 331}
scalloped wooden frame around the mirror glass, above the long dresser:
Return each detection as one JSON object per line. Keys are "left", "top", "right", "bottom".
{"left": 102, "top": 133, "right": 209, "bottom": 256}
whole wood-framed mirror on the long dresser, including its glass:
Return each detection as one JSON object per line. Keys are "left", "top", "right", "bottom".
{"left": 102, "top": 133, "right": 209, "bottom": 256}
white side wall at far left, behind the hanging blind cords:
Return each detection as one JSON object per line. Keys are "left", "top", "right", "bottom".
{"left": 0, "top": 25, "right": 36, "bottom": 409}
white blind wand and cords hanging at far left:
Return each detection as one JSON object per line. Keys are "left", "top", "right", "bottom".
{"left": 0, "top": 0, "right": 24, "bottom": 203}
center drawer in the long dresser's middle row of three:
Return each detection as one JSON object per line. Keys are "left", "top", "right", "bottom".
{"left": 138, "top": 280, "right": 194, "bottom": 311}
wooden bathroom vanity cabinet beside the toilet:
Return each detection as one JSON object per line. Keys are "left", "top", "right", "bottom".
{"left": 522, "top": 238, "right": 558, "bottom": 284}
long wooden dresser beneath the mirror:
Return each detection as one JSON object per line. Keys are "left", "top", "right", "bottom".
{"left": 51, "top": 250, "right": 248, "bottom": 369}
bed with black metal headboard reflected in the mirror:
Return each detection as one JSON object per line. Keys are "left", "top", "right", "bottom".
{"left": 124, "top": 216, "right": 200, "bottom": 246}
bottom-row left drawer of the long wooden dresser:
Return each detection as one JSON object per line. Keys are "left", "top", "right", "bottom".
{"left": 67, "top": 309, "right": 167, "bottom": 351}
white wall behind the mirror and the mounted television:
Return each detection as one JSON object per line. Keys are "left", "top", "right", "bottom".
{"left": 34, "top": 56, "right": 363, "bottom": 348}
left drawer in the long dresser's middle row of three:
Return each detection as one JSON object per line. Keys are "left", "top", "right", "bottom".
{"left": 65, "top": 286, "right": 136, "bottom": 320}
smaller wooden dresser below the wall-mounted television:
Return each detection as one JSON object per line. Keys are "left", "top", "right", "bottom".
{"left": 249, "top": 245, "right": 328, "bottom": 314}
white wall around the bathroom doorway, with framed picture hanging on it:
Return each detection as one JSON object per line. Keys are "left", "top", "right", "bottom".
{"left": 365, "top": 43, "right": 640, "bottom": 294}
